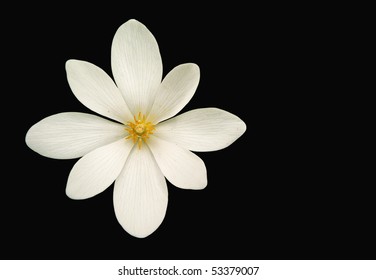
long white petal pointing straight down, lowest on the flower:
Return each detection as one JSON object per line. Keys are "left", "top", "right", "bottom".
{"left": 114, "top": 145, "right": 168, "bottom": 237}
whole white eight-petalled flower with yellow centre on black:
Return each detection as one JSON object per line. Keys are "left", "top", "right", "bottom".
{"left": 26, "top": 20, "right": 246, "bottom": 237}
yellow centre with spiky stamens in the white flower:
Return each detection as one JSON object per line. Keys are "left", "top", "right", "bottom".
{"left": 125, "top": 112, "right": 155, "bottom": 149}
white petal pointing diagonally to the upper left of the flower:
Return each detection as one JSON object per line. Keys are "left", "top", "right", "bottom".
{"left": 65, "top": 59, "right": 133, "bottom": 123}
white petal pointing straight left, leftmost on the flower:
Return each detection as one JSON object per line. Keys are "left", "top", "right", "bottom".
{"left": 25, "top": 112, "right": 126, "bottom": 159}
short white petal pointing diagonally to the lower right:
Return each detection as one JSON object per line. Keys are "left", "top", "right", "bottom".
{"left": 148, "top": 136, "right": 207, "bottom": 190}
